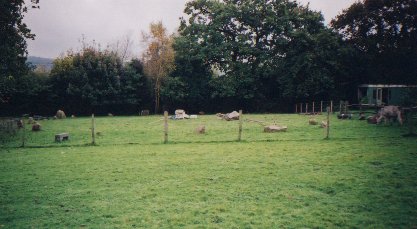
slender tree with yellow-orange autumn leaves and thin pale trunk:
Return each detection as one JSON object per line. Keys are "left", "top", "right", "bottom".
{"left": 143, "top": 22, "right": 175, "bottom": 113}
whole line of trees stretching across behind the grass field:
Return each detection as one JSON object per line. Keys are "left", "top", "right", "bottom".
{"left": 0, "top": 0, "right": 417, "bottom": 115}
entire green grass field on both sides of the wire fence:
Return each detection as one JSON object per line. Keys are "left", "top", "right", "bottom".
{"left": 0, "top": 114, "right": 417, "bottom": 228}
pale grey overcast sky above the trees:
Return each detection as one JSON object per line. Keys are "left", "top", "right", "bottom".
{"left": 25, "top": 0, "right": 356, "bottom": 58}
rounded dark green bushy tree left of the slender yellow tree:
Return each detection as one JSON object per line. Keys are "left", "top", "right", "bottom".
{"left": 51, "top": 45, "right": 147, "bottom": 114}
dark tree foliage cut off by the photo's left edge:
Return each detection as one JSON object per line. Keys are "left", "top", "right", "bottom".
{"left": 0, "top": 0, "right": 39, "bottom": 103}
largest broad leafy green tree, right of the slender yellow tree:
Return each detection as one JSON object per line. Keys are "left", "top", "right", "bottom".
{"left": 180, "top": 0, "right": 341, "bottom": 110}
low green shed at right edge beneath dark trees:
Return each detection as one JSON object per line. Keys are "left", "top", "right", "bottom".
{"left": 358, "top": 84, "right": 417, "bottom": 105}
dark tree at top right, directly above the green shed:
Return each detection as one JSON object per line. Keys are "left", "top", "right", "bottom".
{"left": 331, "top": 0, "right": 417, "bottom": 84}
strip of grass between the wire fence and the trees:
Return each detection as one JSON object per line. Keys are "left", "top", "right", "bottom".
{"left": 0, "top": 109, "right": 416, "bottom": 149}
